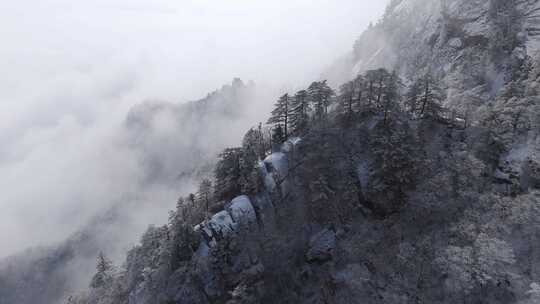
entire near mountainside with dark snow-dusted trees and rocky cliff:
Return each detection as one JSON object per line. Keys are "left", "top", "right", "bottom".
{"left": 66, "top": 0, "right": 540, "bottom": 304}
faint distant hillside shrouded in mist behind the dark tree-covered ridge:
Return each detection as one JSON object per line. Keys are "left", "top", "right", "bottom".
{"left": 0, "top": 79, "right": 260, "bottom": 304}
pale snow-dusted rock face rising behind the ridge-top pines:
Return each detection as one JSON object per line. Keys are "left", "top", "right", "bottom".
{"left": 325, "top": 0, "right": 540, "bottom": 110}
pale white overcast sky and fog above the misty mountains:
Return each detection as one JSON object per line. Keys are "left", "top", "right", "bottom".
{"left": 0, "top": 0, "right": 386, "bottom": 256}
